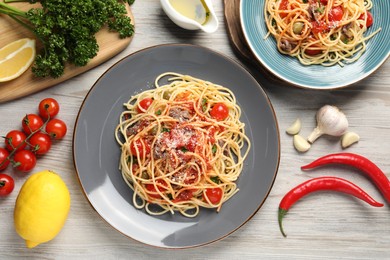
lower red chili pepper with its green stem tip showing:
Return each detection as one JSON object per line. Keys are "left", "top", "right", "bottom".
{"left": 278, "top": 176, "right": 383, "bottom": 237}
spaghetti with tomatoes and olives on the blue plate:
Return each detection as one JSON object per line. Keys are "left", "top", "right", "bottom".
{"left": 264, "top": 0, "right": 381, "bottom": 66}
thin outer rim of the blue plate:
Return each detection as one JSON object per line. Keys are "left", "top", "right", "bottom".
{"left": 239, "top": 0, "right": 390, "bottom": 91}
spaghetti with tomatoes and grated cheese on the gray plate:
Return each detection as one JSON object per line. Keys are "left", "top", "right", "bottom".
{"left": 115, "top": 72, "right": 250, "bottom": 217}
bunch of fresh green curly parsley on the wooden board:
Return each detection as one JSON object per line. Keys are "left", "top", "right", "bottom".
{"left": 0, "top": 0, "right": 134, "bottom": 78}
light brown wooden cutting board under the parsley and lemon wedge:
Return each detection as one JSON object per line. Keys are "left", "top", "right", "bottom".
{"left": 0, "top": 3, "right": 134, "bottom": 103}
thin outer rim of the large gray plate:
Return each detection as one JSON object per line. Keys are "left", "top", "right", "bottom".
{"left": 72, "top": 43, "right": 281, "bottom": 250}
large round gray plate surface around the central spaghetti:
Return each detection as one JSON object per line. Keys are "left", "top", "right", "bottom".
{"left": 73, "top": 44, "right": 280, "bottom": 248}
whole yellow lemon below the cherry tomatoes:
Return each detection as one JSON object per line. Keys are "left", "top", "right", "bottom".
{"left": 14, "top": 170, "right": 70, "bottom": 248}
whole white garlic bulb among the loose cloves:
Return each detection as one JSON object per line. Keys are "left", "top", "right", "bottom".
{"left": 307, "top": 105, "right": 348, "bottom": 143}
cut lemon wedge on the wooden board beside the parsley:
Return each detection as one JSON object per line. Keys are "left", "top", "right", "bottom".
{"left": 0, "top": 38, "right": 35, "bottom": 82}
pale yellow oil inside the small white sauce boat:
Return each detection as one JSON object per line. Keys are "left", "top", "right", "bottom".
{"left": 169, "top": 0, "right": 210, "bottom": 25}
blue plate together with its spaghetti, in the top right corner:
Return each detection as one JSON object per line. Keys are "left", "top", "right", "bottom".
{"left": 240, "top": 0, "right": 390, "bottom": 89}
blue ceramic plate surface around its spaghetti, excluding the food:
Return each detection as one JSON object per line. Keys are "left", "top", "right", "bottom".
{"left": 240, "top": 0, "right": 390, "bottom": 89}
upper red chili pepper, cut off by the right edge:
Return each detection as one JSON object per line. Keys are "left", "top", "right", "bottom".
{"left": 301, "top": 153, "right": 390, "bottom": 203}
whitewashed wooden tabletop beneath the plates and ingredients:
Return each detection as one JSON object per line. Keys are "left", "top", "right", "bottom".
{"left": 0, "top": 0, "right": 390, "bottom": 259}
